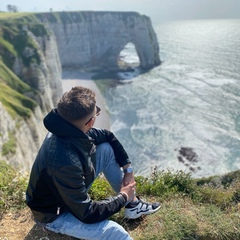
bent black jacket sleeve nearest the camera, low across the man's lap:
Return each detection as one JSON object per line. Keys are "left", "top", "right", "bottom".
{"left": 52, "top": 165, "right": 125, "bottom": 223}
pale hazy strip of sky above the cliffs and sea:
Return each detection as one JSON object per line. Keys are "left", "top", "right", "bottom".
{"left": 0, "top": 0, "right": 240, "bottom": 22}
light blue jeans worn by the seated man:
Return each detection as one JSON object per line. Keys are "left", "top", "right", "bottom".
{"left": 45, "top": 143, "right": 132, "bottom": 240}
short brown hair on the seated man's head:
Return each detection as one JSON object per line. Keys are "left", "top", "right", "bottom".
{"left": 57, "top": 86, "right": 96, "bottom": 123}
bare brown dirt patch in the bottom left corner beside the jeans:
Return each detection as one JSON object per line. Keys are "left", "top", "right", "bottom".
{"left": 0, "top": 208, "right": 76, "bottom": 240}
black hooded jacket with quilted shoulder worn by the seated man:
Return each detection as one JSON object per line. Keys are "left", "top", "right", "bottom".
{"left": 26, "top": 109, "right": 130, "bottom": 223}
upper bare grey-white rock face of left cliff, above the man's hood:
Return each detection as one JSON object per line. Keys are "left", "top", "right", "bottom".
{"left": 13, "top": 26, "right": 62, "bottom": 111}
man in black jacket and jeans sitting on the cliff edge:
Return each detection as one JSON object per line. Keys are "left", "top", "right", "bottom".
{"left": 26, "top": 86, "right": 160, "bottom": 240}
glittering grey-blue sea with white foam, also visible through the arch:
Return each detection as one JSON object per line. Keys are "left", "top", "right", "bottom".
{"left": 68, "top": 19, "right": 240, "bottom": 178}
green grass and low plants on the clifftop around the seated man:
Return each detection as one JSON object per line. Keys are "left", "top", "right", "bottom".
{"left": 0, "top": 161, "right": 240, "bottom": 240}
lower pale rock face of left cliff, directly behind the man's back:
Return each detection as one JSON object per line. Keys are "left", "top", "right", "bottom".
{"left": 0, "top": 102, "right": 46, "bottom": 171}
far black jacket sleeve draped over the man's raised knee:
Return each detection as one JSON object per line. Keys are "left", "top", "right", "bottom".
{"left": 88, "top": 128, "right": 131, "bottom": 167}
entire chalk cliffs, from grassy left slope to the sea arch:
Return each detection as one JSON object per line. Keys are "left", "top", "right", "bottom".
{"left": 0, "top": 12, "right": 160, "bottom": 171}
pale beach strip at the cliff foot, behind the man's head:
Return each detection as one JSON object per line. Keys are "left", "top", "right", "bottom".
{"left": 62, "top": 71, "right": 110, "bottom": 130}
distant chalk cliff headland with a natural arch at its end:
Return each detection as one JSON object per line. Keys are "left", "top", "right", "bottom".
{"left": 40, "top": 12, "right": 160, "bottom": 70}
